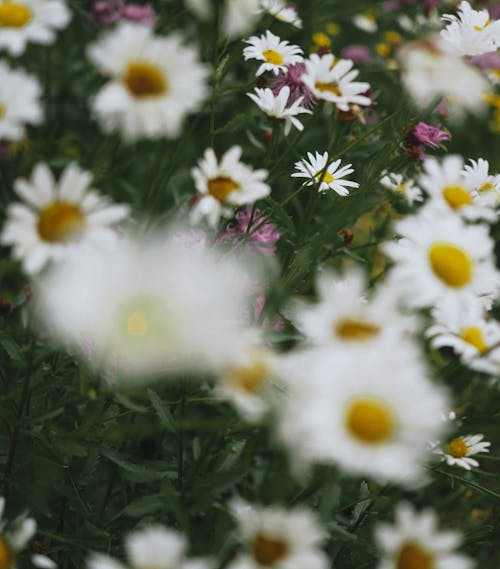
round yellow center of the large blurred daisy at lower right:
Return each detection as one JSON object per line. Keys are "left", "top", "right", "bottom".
{"left": 345, "top": 397, "right": 396, "bottom": 445}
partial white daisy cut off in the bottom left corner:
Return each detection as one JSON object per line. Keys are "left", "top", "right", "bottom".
{"left": 0, "top": 496, "right": 56, "bottom": 569}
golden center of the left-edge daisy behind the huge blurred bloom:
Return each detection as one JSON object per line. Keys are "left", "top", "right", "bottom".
{"left": 37, "top": 201, "right": 85, "bottom": 243}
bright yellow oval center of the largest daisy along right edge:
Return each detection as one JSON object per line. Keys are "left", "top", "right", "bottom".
{"left": 429, "top": 243, "right": 474, "bottom": 288}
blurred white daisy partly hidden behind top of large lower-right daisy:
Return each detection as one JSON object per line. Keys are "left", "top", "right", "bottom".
{"left": 287, "top": 269, "right": 416, "bottom": 349}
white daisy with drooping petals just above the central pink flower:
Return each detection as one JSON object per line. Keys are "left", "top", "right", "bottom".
{"left": 191, "top": 146, "right": 271, "bottom": 227}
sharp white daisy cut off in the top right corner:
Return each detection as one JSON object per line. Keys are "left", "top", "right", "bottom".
{"left": 441, "top": 0, "right": 500, "bottom": 55}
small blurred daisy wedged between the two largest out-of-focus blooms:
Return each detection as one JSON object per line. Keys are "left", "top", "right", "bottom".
{"left": 215, "top": 339, "right": 280, "bottom": 421}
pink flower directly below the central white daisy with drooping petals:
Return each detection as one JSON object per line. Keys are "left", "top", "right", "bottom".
{"left": 217, "top": 205, "right": 281, "bottom": 255}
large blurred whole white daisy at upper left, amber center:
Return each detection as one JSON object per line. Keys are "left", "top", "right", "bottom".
{"left": 88, "top": 23, "right": 207, "bottom": 141}
